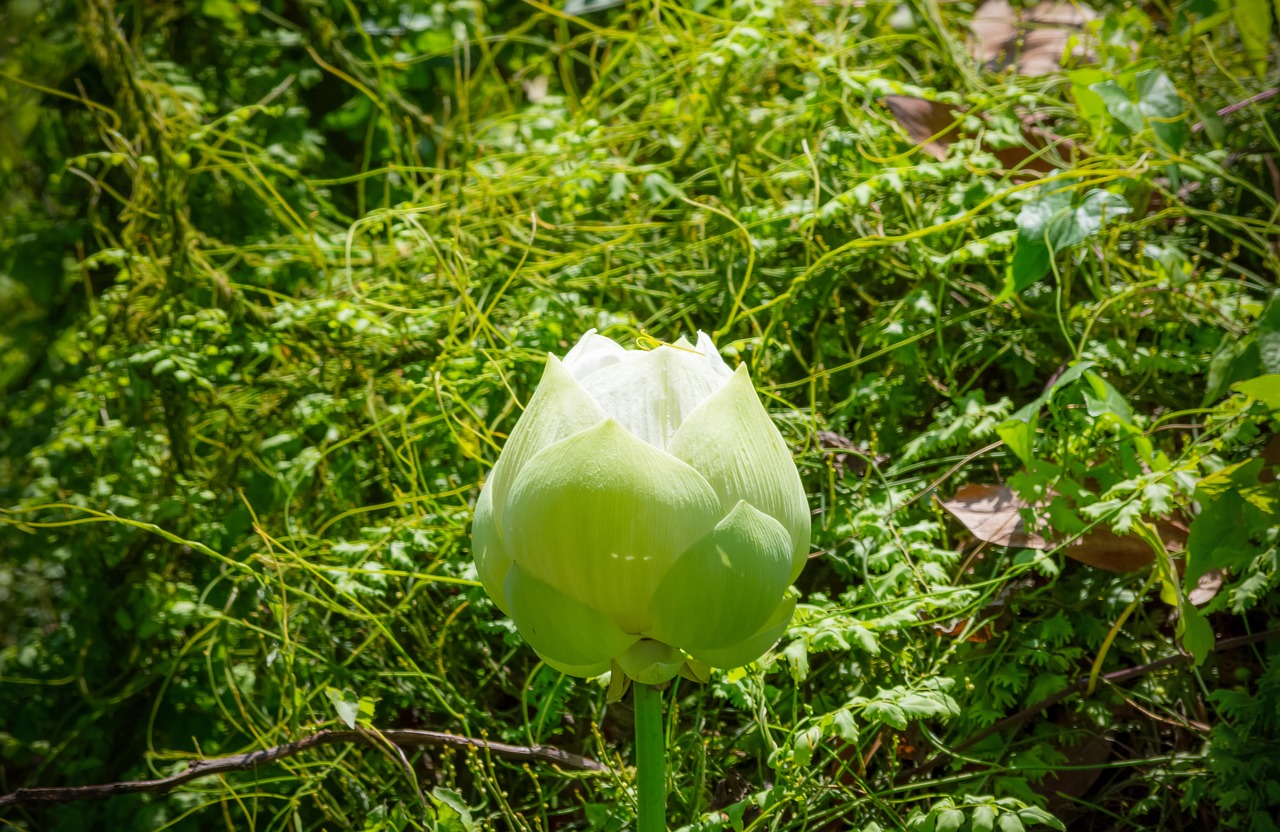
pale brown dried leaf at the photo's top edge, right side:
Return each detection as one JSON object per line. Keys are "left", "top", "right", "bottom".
{"left": 970, "top": 0, "right": 1097, "bottom": 77}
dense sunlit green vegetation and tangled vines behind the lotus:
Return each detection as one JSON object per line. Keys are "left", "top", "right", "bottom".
{"left": 0, "top": 0, "right": 1280, "bottom": 832}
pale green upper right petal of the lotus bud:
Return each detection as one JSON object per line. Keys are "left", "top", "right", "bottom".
{"left": 667, "top": 365, "right": 809, "bottom": 581}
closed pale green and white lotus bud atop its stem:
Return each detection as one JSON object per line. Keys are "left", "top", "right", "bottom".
{"left": 472, "top": 329, "right": 809, "bottom": 685}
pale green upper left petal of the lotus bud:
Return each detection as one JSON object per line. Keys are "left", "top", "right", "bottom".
{"left": 489, "top": 355, "right": 604, "bottom": 535}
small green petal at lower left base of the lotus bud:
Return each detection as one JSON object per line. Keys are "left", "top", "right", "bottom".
{"left": 506, "top": 566, "right": 639, "bottom": 672}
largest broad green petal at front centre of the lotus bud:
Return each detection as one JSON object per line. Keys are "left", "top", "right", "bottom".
{"left": 503, "top": 419, "right": 722, "bottom": 635}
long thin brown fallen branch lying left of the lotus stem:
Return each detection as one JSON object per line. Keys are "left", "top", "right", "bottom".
{"left": 0, "top": 728, "right": 608, "bottom": 806}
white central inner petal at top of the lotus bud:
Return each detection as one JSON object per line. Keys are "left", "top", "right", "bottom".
{"left": 582, "top": 346, "right": 726, "bottom": 448}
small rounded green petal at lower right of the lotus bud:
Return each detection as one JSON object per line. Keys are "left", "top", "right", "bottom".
{"left": 645, "top": 500, "right": 791, "bottom": 650}
